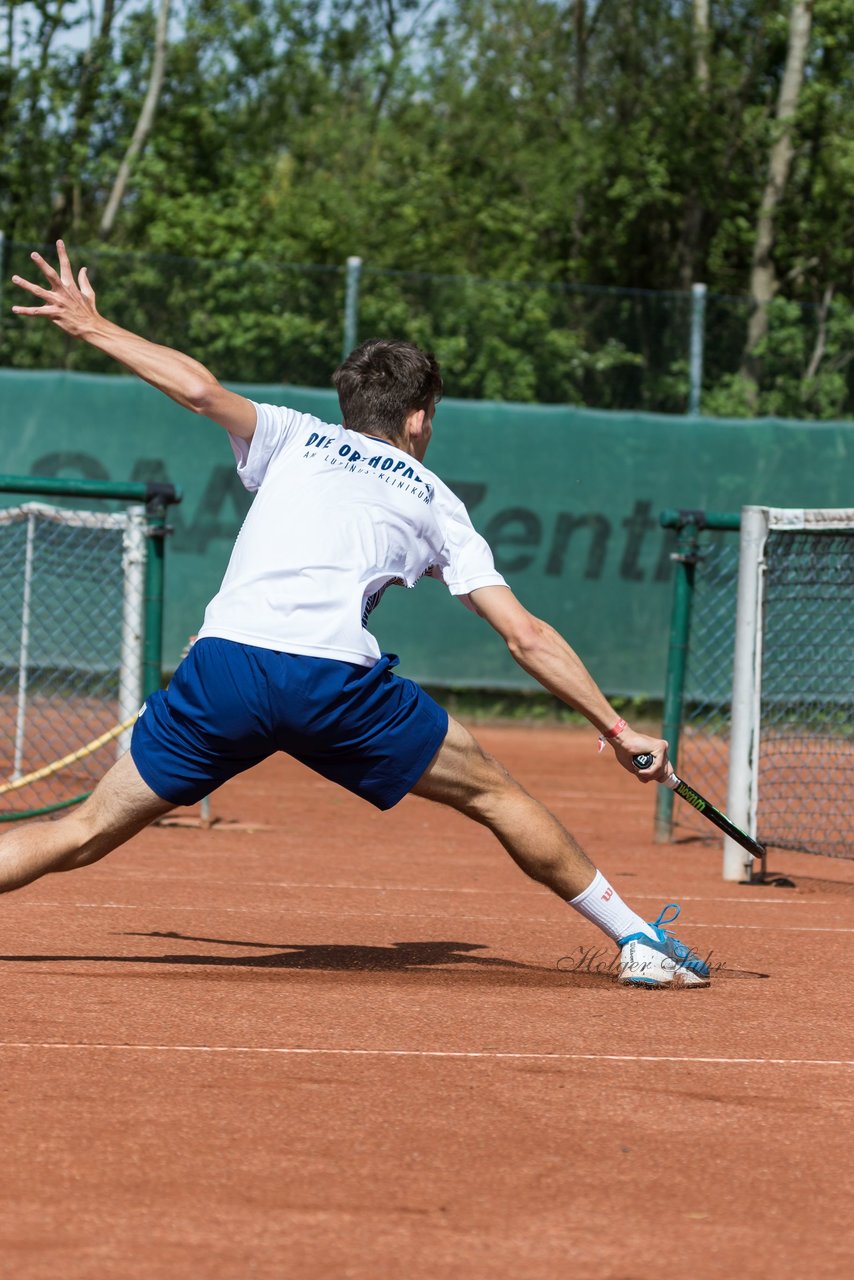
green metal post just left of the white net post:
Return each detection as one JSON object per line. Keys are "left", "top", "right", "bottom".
{"left": 656, "top": 512, "right": 702, "bottom": 844}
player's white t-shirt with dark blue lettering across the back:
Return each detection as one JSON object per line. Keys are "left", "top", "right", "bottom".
{"left": 198, "top": 404, "right": 506, "bottom": 667}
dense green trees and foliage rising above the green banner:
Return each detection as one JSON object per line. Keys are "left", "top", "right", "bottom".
{"left": 0, "top": 0, "right": 854, "bottom": 417}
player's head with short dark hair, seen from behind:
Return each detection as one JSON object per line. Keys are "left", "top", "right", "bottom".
{"left": 332, "top": 338, "right": 442, "bottom": 440}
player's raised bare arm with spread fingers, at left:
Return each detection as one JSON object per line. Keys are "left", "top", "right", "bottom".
{"left": 12, "top": 241, "right": 255, "bottom": 440}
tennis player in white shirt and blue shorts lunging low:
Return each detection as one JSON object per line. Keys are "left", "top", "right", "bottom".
{"left": 6, "top": 241, "right": 709, "bottom": 987}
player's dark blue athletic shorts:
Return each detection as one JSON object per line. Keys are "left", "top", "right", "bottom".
{"left": 131, "top": 636, "right": 448, "bottom": 809}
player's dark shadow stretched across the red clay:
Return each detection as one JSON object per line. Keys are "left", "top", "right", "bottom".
{"left": 1, "top": 931, "right": 609, "bottom": 987}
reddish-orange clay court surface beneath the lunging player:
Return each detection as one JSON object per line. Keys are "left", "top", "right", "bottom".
{"left": 0, "top": 727, "right": 854, "bottom": 1280}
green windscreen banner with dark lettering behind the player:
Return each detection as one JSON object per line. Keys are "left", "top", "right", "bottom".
{"left": 0, "top": 370, "right": 854, "bottom": 698}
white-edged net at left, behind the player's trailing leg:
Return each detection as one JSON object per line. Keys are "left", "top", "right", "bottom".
{"left": 0, "top": 502, "right": 145, "bottom": 814}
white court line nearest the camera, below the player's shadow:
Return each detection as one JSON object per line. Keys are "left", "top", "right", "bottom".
{"left": 0, "top": 1041, "right": 854, "bottom": 1066}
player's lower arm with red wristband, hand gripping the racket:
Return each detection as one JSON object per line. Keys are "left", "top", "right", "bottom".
{"left": 469, "top": 586, "right": 672, "bottom": 782}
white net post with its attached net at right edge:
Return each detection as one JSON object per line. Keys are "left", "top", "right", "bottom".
{"left": 723, "top": 507, "right": 854, "bottom": 879}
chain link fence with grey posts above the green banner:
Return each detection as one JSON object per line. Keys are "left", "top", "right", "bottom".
{"left": 0, "top": 236, "right": 854, "bottom": 419}
